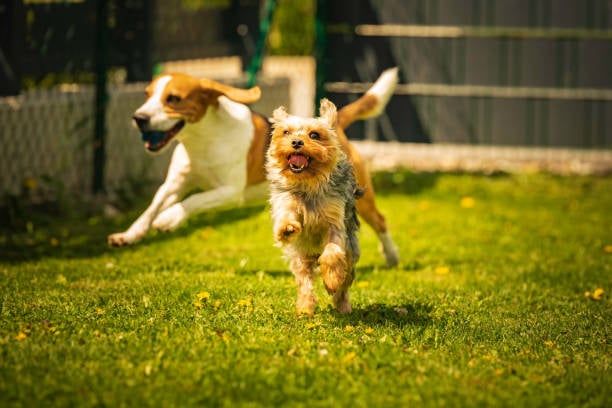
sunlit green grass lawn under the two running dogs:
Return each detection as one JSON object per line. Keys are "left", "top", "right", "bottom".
{"left": 0, "top": 173, "right": 612, "bottom": 407}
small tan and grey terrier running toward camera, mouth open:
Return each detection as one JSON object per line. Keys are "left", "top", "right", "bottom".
{"left": 266, "top": 99, "right": 363, "bottom": 316}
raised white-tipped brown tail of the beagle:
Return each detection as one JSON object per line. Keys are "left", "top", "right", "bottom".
{"left": 338, "top": 67, "right": 398, "bottom": 129}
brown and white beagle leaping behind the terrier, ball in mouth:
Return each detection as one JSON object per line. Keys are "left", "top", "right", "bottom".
{"left": 108, "top": 68, "right": 399, "bottom": 266}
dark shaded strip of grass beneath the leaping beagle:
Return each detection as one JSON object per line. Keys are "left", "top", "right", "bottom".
{"left": 0, "top": 206, "right": 264, "bottom": 263}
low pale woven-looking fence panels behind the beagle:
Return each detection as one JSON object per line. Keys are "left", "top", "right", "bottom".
{"left": 0, "top": 66, "right": 291, "bottom": 201}
